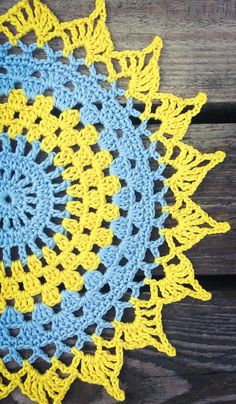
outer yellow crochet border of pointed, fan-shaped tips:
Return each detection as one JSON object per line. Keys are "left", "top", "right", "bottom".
{"left": 0, "top": 0, "right": 230, "bottom": 403}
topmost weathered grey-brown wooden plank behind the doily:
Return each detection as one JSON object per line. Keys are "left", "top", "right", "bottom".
{"left": 0, "top": 0, "right": 236, "bottom": 102}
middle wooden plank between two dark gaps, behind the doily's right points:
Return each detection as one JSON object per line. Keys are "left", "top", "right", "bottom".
{"left": 150, "top": 124, "right": 236, "bottom": 275}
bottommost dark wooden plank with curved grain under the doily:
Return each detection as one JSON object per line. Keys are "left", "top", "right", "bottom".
{"left": 2, "top": 291, "right": 236, "bottom": 404}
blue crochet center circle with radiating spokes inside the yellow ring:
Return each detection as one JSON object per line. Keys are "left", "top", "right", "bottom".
{"left": 0, "top": 134, "right": 71, "bottom": 266}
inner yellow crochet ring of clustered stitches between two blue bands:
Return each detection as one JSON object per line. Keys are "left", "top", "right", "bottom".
{"left": 0, "top": 90, "right": 119, "bottom": 313}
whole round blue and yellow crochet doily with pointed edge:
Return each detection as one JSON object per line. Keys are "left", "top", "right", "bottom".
{"left": 0, "top": 0, "right": 229, "bottom": 403}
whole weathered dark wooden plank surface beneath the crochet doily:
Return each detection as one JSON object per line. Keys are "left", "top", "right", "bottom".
{"left": 0, "top": 0, "right": 236, "bottom": 404}
